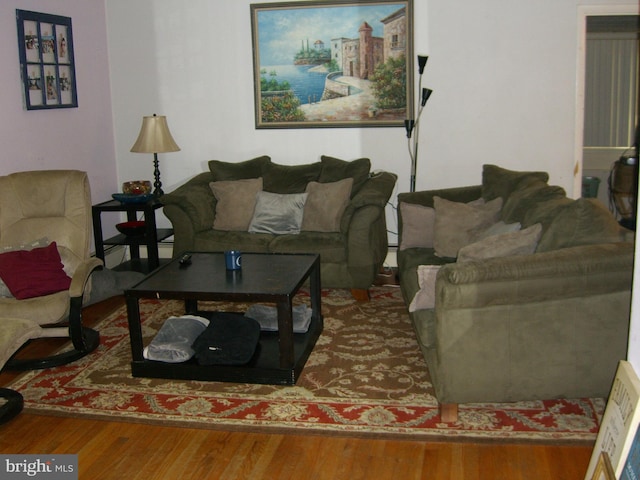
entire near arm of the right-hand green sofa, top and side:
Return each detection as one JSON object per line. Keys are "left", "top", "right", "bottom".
{"left": 428, "top": 243, "right": 634, "bottom": 403}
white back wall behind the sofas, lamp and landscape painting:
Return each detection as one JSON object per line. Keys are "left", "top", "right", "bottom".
{"left": 106, "top": 0, "right": 637, "bottom": 228}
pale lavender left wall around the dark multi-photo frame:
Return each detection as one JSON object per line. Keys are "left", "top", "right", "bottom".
{"left": 0, "top": 0, "right": 117, "bottom": 201}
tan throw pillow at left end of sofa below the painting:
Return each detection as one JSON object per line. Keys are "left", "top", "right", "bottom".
{"left": 209, "top": 178, "right": 262, "bottom": 232}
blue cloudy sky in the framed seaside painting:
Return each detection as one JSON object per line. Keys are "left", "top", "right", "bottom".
{"left": 256, "top": 3, "right": 404, "bottom": 66}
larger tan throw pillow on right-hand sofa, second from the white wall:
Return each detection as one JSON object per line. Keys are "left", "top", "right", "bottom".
{"left": 433, "top": 197, "right": 502, "bottom": 258}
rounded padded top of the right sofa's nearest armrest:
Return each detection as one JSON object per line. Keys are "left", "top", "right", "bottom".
{"left": 436, "top": 242, "right": 634, "bottom": 309}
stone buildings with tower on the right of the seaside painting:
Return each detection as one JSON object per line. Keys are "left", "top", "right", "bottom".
{"left": 331, "top": 8, "right": 407, "bottom": 79}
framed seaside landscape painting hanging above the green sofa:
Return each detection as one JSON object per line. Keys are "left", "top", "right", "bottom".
{"left": 251, "top": 0, "right": 413, "bottom": 128}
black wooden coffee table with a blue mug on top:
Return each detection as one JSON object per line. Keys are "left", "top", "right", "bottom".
{"left": 125, "top": 252, "right": 323, "bottom": 385}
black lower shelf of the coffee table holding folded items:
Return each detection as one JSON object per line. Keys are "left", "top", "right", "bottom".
{"left": 131, "top": 312, "right": 322, "bottom": 385}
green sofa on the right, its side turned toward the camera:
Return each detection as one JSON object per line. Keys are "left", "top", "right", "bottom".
{"left": 398, "top": 165, "right": 634, "bottom": 421}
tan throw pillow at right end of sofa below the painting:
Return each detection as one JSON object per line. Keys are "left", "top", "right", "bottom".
{"left": 302, "top": 178, "right": 353, "bottom": 232}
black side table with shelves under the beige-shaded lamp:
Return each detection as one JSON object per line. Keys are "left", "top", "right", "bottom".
{"left": 91, "top": 198, "right": 173, "bottom": 273}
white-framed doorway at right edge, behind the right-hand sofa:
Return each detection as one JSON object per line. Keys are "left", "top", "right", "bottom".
{"left": 574, "top": 5, "right": 640, "bottom": 206}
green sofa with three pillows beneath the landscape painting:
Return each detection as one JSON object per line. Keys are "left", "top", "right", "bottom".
{"left": 162, "top": 156, "right": 396, "bottom": 298}
